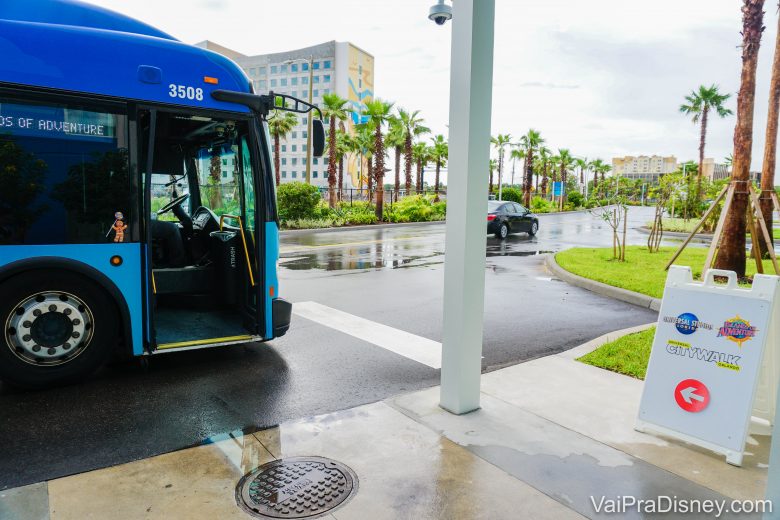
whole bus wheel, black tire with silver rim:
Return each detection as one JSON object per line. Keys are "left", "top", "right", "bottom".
{"left": 0, "top": 270, "right": 119, "bottom": 388}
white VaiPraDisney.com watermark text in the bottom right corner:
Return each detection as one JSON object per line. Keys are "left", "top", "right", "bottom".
{"left": 590, "top": 495, "right": 772, "bottom": 518}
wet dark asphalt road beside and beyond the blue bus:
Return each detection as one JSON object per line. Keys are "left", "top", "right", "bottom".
{"left": 0, "top": 208, "right": 655, "bottom": 489}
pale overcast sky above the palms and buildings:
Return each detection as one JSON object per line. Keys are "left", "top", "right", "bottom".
{"left": 91, "top": 0, "right": 777, "bottom": 169}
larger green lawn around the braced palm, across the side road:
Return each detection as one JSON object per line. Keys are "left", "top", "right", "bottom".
{"left": 555, "top": 246, "right": 756, "bottom": 298}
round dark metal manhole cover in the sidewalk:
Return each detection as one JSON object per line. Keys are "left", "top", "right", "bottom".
{"left": 236, "top": 457, "right": 358, "bottom": 518}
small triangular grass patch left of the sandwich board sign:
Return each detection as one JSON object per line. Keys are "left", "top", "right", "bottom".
{"left": 577, "top": 327, "right": 655, "bottom": 379}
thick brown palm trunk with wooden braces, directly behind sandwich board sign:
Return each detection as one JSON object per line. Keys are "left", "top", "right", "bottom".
{"left": 715, "top": 0, "right": 764, "bottom": 276}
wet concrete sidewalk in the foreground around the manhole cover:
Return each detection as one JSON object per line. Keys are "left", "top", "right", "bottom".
{"left": 0, "top": 327, "right": 769, "bottom": 520}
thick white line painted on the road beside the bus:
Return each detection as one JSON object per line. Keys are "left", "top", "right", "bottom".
{"left": 293, "top": 302, "right": 441, "bottom": 368}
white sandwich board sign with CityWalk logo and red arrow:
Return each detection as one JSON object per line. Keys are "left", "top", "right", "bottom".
{"left": 636, "top": 266, "right": 780, "bottom": 466}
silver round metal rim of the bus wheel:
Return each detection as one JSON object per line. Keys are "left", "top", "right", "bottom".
{"left": 5, "top": 291, "right": 94, "bottom": 366}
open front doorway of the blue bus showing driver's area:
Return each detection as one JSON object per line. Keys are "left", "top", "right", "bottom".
{"left": 141, "top": 110, "right": 264, "bottom": 352}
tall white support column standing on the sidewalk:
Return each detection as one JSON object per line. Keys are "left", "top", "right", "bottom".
{"left": 440, "top": 0, "right": 495, "bottom": 414}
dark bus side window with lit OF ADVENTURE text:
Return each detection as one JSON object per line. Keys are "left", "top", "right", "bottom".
{"left": 0, "top": 98, "right": 131, "bottom": 244}
